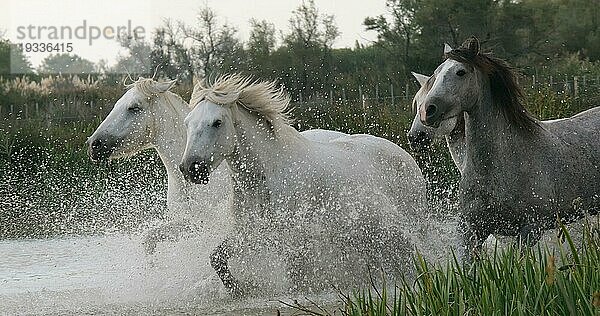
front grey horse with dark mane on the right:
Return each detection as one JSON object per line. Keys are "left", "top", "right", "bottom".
{"left": 419, "top": 38, "right": 600, "bottom": 260}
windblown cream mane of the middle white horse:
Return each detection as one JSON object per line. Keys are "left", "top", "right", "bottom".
{"left": 190, "top": 74, "right": 292, "bottom": 124}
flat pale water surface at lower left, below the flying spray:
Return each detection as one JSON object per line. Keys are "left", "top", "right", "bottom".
{"left": 0, "top": 234, "right": 334, "bottom": 315}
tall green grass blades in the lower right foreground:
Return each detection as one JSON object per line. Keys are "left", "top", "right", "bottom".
{"left": 332, "top": 221, "right": 600, "bottom": 316}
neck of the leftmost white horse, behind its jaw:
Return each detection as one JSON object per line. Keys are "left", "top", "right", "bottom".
{"left": 154, "top": 92, "right": 189, "bottom": 203}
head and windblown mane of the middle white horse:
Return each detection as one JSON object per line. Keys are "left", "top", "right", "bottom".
{"left": 179, "top": 74, "right": 289, "bottom": 184}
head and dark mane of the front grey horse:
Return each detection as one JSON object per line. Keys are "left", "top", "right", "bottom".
{"left": 418, "top": 37, "right": 537, "bottom": 135}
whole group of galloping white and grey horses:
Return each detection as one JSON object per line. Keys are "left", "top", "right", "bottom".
{"left": 88, "top": 37, "right": 600, "bottom": 296}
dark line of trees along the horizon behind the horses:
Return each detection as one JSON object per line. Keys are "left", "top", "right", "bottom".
{"left": 0, "top": 0, "right": 600, "bottom": 98}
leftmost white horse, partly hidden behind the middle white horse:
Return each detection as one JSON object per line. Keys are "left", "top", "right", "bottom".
{"left": 88, "top": 78, "right": 231, "bottom": 253}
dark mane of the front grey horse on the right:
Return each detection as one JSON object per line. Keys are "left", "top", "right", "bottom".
{"left": 446, "top": 43, "right": 540, "bottom": 133}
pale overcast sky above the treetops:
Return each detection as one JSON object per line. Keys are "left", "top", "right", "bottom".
{"left": 0, "top": 0, "right": 385, "bottom": 66}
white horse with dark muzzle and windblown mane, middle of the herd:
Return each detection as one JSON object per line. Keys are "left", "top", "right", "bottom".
{"left": 180, "top": 75, "right": 426, "bottom": 294}
